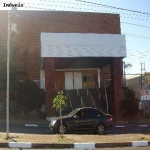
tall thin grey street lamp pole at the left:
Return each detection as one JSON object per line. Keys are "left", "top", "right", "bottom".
{"left": 6, "top": 7, "right": 17, "bottom": 139}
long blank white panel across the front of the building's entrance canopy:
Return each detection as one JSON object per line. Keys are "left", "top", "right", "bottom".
{"left": 41, "top": 32, "right": 126, "bottom": 58}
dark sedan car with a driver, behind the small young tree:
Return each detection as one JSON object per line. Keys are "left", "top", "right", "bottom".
{"left": 49, "top": 107, "right": 113, "bottom": 134}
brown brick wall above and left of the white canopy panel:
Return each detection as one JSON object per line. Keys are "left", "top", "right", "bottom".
{"left": 0, "top": 10, "right": 121, "bottom": 80}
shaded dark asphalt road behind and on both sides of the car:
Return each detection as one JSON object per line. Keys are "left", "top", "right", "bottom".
{"left": 0, "top": 124, "right": 150, "bottom": 135}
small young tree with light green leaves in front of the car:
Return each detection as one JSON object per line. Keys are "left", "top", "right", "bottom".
{"left": 53, "top": 91, "right": 67, "bottom": 138}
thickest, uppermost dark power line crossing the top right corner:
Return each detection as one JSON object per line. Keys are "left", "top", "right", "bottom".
{"left": 76, "top": 0, "right": 150, "bottom": 16}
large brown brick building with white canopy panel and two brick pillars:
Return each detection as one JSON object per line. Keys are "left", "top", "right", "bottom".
{"left": 0, "top": 11, "right": 126, "bottom": 117}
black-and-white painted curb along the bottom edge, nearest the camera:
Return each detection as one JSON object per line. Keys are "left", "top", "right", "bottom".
{"left": 4, "top": 141, "right": 150, "bottom": 149}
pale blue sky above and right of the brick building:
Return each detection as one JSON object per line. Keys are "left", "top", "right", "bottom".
{"left": 0, "top": 0, "right": 150, "bottom": 77}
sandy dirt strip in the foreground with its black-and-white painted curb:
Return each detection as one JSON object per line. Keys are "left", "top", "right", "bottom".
{"left": 0, "top": 134, "right": 150, "bottom": 149}
